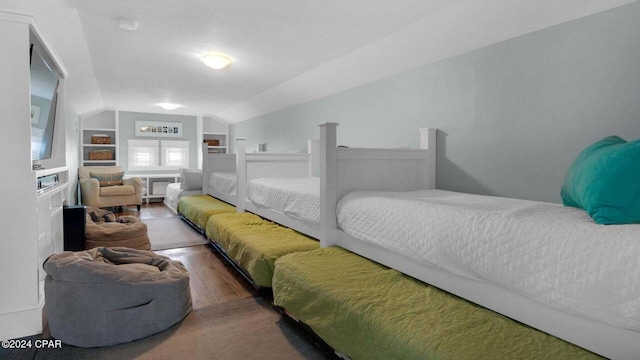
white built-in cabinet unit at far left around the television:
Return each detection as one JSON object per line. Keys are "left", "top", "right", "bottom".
{"left": 0, "top": 11, "right": 70, "bottom": 340}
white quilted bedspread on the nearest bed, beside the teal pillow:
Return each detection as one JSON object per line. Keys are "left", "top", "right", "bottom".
{"left": 337, "top": 190, "right": 640, "bottom": 331}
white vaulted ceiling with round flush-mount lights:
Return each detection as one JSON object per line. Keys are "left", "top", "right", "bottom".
{"left": 0, "top": 0, "right": 633, "bottom": 123}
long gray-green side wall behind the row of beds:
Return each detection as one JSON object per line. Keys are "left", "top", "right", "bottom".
{"left": 230, "top": 2, "right": 640, "bottom": 202}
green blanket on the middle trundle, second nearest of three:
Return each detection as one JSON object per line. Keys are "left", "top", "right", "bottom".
{"left": 205, "top": 213, "right": 320, "bottom": 287}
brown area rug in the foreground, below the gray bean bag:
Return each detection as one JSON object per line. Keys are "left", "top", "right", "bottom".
{"left": 35, "top": 297, "right": 330, "bottom": 360}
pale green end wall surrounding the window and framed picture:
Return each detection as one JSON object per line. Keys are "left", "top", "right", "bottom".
{"left": 118, "top": 111, "right": 200, "bottom": 173}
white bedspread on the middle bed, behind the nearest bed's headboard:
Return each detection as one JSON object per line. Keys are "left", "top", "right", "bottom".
{"left": 247, "top": 177, "right": 320, "bottom": 224}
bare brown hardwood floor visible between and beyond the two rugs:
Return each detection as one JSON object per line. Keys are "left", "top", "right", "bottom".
{"left": 116, "top": 203, "right": 257, "bottom": 309}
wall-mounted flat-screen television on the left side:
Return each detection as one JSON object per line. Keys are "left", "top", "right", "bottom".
{"left": 30, "top": 45, "right": 60, "bottom": 161}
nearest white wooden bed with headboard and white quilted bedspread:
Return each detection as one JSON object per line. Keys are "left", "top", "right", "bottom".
{"left": 319, "top": 123, "right": 640, "bottom": 359}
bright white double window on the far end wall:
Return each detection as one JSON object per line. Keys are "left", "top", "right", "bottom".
{"left": 128, "top": 139, "right": 189, "bottom": 170}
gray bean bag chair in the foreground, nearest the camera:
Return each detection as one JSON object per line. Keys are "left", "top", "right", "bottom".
{"left": 44, "top": 247, "right": 192, "bottom": 347}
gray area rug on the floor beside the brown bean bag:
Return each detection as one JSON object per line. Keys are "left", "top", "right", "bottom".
{"left": 143, "top": 216, "right": 209, "bottom": 250}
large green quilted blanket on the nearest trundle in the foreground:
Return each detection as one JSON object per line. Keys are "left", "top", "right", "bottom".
{"left": 273, "top": 247, "right": 598, "bottom": 360}
